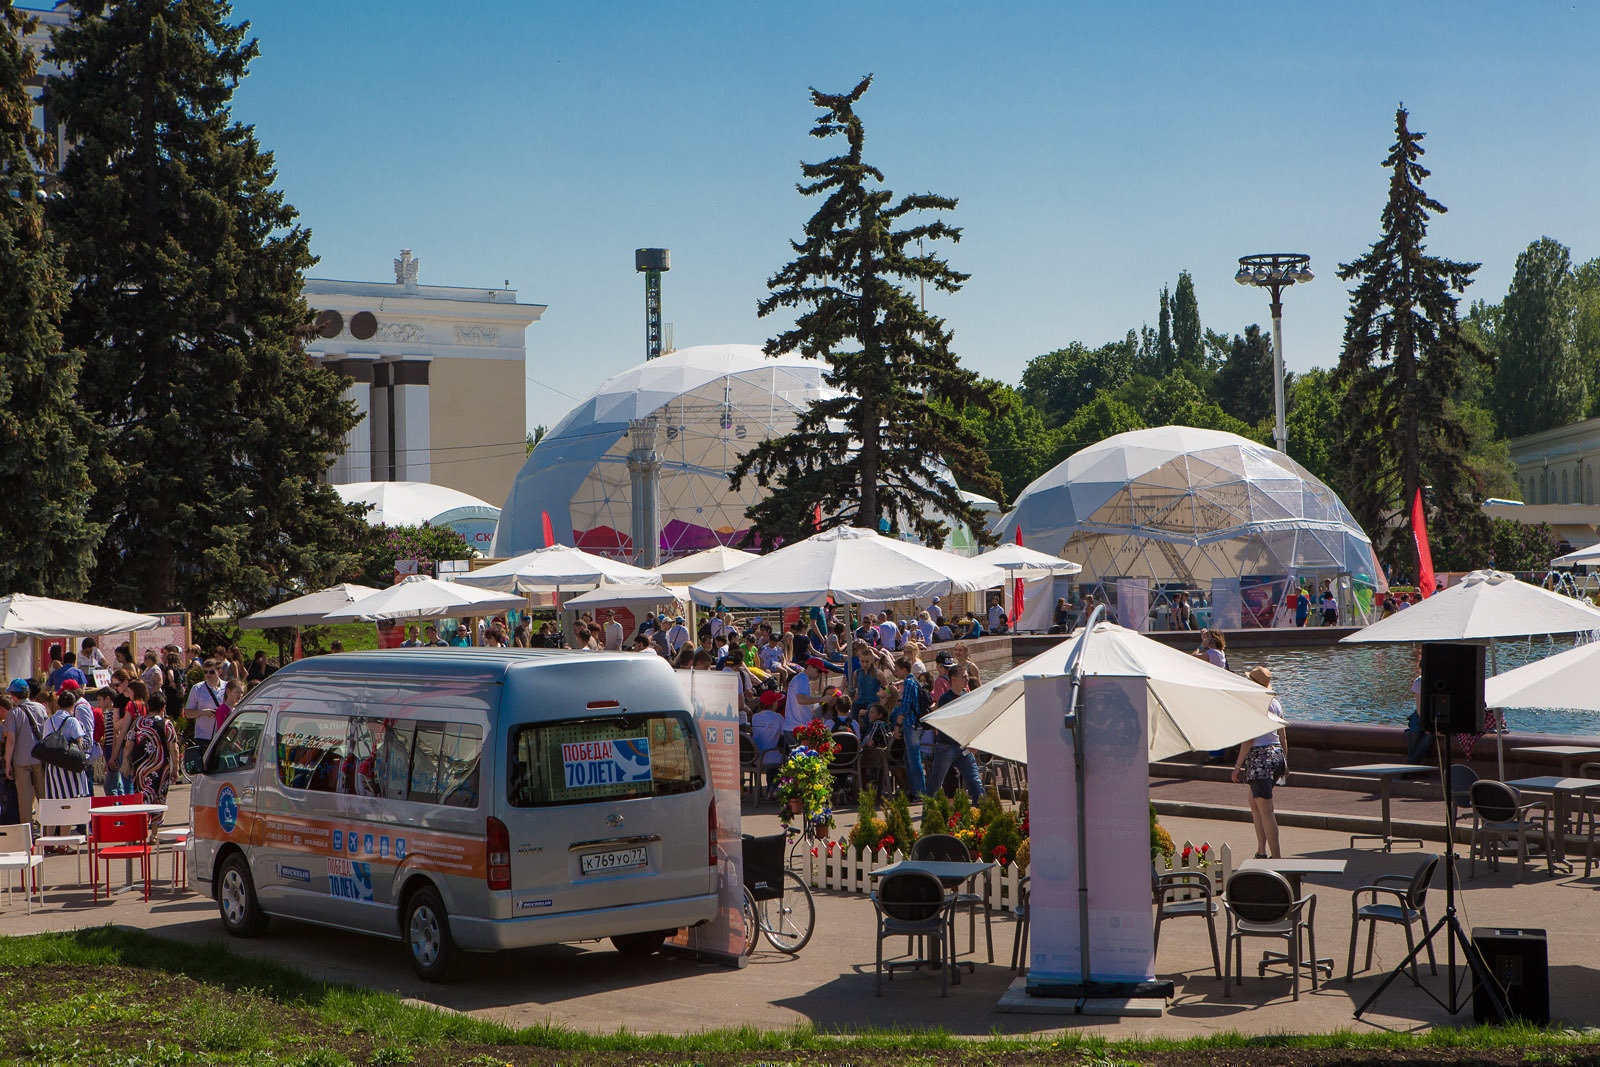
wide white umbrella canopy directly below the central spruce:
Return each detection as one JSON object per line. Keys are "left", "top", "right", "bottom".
{"left": 690, "top": 526, "right": 1006, "bottom": 608}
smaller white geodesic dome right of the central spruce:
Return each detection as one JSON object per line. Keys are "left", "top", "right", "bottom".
{"left": 997, "top": 426, "right": 1384, "bottom": 629}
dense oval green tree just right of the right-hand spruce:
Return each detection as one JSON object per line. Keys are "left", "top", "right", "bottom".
{"left": 1494, "top": 237, "right": 1589, "bottom": 437}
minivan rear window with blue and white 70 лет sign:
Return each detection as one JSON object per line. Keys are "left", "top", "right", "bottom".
{"left": 507, "top": 712, "right": 706, "bottom": 808}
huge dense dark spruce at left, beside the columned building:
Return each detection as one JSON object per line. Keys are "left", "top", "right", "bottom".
{"left": 46, "top": 0, "right": 358, "bottom": 613}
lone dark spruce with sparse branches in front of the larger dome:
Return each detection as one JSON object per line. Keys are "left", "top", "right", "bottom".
{"left": 731, "top": 75, "right": 1000, "bottom": 545}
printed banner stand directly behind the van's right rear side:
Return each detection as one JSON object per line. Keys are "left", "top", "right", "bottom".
{"left": 661, "top": 670, "right": 749, "bottom": 968}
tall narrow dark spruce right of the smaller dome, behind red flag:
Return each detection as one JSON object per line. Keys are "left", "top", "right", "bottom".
{"left": 1333, "top": 107, "right": 1490, "bottom": 566}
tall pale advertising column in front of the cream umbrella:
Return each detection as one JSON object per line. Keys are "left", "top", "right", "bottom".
{"left": 1026, "top": 677, "right": 1155, "bottom": 997}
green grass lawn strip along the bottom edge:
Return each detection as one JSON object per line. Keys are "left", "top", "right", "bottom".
{"left": 0, "top": 926, "right": 1600, "bottom": 1067}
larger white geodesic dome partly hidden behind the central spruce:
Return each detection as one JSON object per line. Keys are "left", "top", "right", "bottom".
{"left": 494, "top": 344, "right": 832, "bottom": 560}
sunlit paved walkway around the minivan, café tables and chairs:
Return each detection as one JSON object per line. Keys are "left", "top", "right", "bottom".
{"left": 0, "top": 784, "right": 1600, "bottom": 1038}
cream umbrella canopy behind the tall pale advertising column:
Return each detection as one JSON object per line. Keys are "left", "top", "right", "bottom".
{"left": 923, "top": 622, "right": 1283, "bottom": 761}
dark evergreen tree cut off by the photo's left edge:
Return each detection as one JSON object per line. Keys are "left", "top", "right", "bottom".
{"left": 0, "top": 0, "right": 101, "bottom": 598}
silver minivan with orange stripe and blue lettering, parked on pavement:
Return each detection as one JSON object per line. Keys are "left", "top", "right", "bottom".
{"left": 192, "top": 648, "right": 718, "bottom": 981}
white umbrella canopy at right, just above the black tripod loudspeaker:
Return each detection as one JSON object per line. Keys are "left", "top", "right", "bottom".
{"left": 1342, "top": 571, "right": 1600, "bottom": 643}
